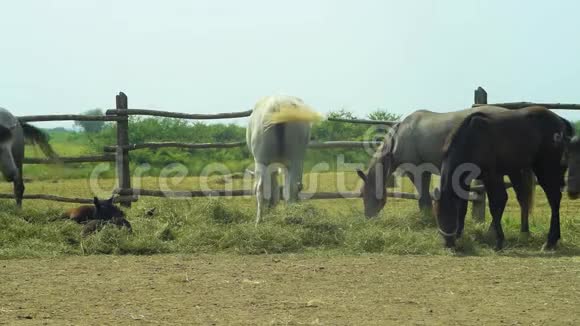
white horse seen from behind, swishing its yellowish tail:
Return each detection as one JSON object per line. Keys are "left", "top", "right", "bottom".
{"left": 246, "top": 96, "right": 322, "bottom": 224}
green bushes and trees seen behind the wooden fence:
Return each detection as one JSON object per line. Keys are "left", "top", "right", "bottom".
{"left": 64, "top": 109, "right": 401, "bottom": 175}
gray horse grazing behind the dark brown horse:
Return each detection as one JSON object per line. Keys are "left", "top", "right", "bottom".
{"left": 357, "top": 105, "right": 534, "bottom": 233}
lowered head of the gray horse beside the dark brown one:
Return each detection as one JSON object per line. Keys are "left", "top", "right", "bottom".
{"left": 356, "top": 153, "right": 393, "bottom": 218}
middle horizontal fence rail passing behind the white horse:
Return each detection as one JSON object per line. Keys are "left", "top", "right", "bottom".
{"left": 104, "top": 141, "right": 382, "bottom": 152}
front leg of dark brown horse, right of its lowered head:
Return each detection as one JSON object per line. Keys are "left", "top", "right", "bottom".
{"left": 483, "top": 175, "right": 508, "bottom": 250}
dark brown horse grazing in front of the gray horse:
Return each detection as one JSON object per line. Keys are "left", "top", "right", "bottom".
{"left": 437, "top": 106, "right": 577, "bottom": 250}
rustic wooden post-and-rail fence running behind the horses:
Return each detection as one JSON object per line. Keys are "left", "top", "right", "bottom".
{"left": 6, "top": 87, "right": 580, "bottom": 219}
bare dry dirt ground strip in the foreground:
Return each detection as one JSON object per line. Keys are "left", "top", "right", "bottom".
{"left": 0, "top": 255, "right": 580, "bottom": 325}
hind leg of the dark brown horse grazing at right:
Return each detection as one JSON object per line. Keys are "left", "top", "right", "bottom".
{"left": 534, "top": 168, "right": 562, "bottom": 250}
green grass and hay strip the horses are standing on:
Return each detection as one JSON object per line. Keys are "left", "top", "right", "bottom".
{"left": 0, "top": 173, "right": 580, "bottom": 258}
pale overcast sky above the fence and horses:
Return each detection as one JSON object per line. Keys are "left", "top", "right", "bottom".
{"left": 0, "top": 0, "right": 580, "bottom": 127}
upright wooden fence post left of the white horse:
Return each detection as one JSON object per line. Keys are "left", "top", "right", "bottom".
{"left": 115, "top": 92, "right": 132, "bottom": 207}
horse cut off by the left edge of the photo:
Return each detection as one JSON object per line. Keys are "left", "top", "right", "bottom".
{"left": 0, "top": 108, "right": 57, "bottom": 207}
